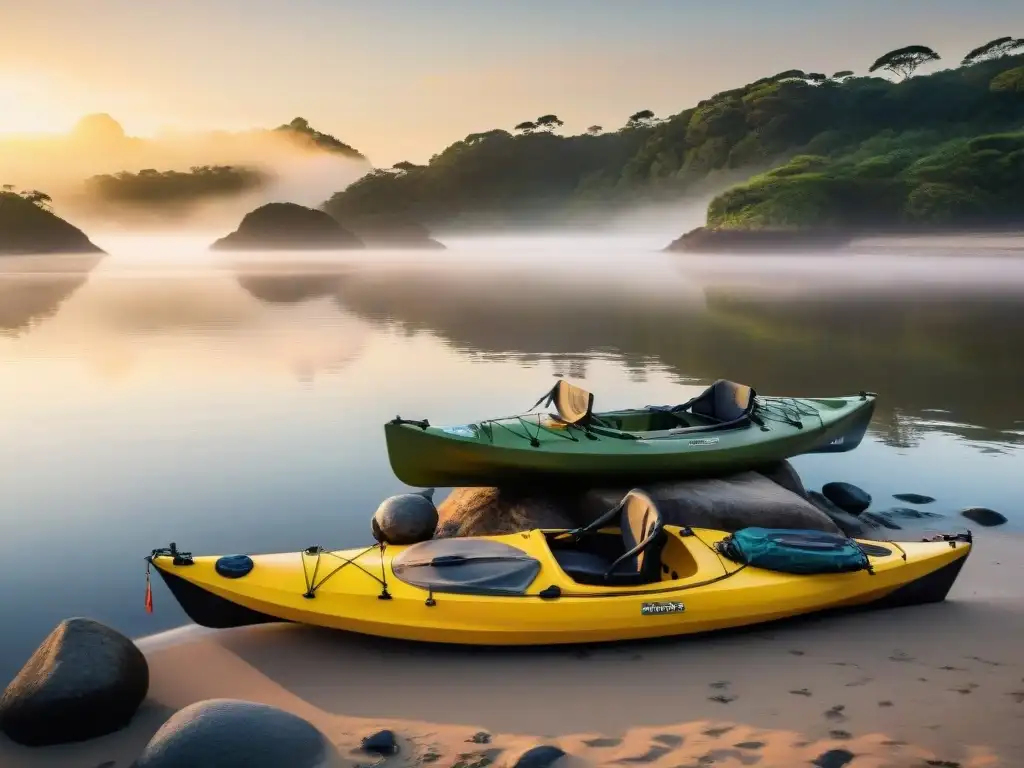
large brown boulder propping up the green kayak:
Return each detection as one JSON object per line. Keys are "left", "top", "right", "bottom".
{"left": 437, "top": 472, "right": 840, "bottom": 537}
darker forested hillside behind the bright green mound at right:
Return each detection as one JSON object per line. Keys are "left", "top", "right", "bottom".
{"left": 326, "top": 41, "right": 1024, "bottom": 226}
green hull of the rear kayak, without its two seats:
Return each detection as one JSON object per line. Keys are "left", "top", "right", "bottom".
{"left": 384, "top": 394, "right": 876, "bottom": 487}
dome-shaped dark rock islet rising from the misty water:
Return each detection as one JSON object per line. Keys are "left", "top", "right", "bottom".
{"left": 211, "top": 203, "right": 365, "bottom": 251}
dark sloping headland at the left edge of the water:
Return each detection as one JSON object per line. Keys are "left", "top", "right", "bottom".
{"left": 0, "top": 191, "right": 102, "bottom": 256}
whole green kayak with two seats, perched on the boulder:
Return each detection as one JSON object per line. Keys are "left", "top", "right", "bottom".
{"left": 384, "top": 380, "right": 877, "bottom": 487}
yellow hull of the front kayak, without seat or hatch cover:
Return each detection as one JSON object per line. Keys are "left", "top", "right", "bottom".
{"left": 152, "top": 526, "right": 973, "bottom": 645}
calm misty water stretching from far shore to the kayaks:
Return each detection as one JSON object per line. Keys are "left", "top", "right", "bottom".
{"left": 0, "top": 239, "right": 1024, "bottom": 680}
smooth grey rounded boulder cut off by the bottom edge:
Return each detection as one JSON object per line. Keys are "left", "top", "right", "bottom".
{"left": 132, "top": 698, "right": 334, "bottom": 768}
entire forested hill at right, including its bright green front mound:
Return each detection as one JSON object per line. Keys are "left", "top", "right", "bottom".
{"left": 324, "top": 37, "right": 1024, "bottom": 227}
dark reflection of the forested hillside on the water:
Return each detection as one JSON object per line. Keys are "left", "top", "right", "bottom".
{"left": 232, "top": 265, "right": 1024, "bottom": 447}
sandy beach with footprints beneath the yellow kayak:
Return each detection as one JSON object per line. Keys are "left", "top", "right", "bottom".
{"left": 0, "top": 534, "right": 1024, "bottom": 768}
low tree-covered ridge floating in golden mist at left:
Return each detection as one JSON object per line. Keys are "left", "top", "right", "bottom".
{"left": 85, "top": 166, "right": 268, "bottom": 207}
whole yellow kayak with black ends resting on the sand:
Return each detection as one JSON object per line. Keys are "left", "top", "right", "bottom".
{"left": 146, "top": 490, "right": 972, "bottom": 645}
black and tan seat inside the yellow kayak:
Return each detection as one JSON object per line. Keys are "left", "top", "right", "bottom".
{"left": 553, "top": 488, "right": 667, "bottom": 586}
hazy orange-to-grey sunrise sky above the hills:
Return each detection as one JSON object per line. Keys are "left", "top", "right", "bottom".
{"left": 0, "top": 0, "right": 1024, "bottom": 165}
